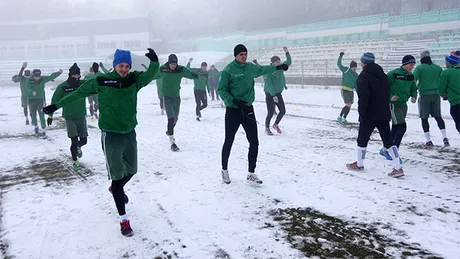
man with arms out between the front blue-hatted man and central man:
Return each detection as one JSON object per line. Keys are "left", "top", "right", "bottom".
{"left": 155, "top": 54, "right": 198, "bottom": 151}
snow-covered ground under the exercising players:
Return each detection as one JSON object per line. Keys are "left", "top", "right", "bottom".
{"left": 0, "top": 85, "right": 460, "bottom": 259}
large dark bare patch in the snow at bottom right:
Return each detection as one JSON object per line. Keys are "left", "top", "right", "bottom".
{"left": 266, "top": 208, "right": 442, "bottom": 258}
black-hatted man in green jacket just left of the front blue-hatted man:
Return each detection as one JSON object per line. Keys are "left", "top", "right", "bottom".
{"left": 47, "top": 63, "right": 88, "bottom": 169}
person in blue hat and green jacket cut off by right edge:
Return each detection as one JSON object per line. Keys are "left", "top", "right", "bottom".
{"left": 439, "top": 50, "right": 460, "bottom": 133}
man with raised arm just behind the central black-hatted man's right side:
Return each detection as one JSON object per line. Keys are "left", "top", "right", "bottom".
{"left": 258, "top": 47, "right": 292, "bottom": 136}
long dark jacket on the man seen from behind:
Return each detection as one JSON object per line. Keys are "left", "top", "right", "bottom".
{"left": 356, "top": 64, "right": 391, "bottom": 122}
